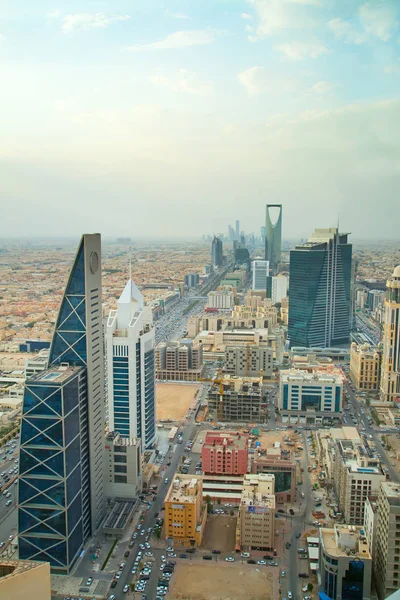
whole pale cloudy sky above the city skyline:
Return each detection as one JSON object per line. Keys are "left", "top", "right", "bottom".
{"left": 0, "top": 0, "right": 400, "bottom": 238}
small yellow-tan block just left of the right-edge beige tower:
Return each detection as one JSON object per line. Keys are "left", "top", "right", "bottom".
{"left": 350, "top": 342, "right": 381, "bottom": 391}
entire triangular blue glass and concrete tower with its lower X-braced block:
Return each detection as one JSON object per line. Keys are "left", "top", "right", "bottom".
{"left": 18, "top": 234, "right": 105, "bottom": 574}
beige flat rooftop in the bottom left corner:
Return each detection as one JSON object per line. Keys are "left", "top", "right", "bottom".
{"left": 0, "top": 557, "right": 51, "bottom": 600}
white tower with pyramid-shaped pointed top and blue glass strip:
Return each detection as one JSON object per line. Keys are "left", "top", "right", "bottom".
{"left": 105, "top": 279, "right": 156, "bottom": 451}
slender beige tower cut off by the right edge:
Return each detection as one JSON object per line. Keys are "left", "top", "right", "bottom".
{"left": 381, "top": 265, "right": 400, "bottom": 404}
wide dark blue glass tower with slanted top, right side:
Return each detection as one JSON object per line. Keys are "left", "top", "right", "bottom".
{"left": 288, "top": 228, "right": 352, "bottom": 348}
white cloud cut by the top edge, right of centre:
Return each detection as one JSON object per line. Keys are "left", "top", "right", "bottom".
{"left": 247, "top": 0, "right": 320, "bottom": 41}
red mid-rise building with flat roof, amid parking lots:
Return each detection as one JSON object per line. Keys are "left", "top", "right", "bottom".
{"left": 201, "top": 431, "right": 249, "bottom": 475}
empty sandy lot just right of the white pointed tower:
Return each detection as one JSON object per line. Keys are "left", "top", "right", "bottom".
{"left": 156, "top": 383, "right": 201, "bottom": 421}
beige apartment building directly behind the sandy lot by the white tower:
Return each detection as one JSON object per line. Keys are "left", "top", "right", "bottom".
{"left": 155, "top": 340, "right": 204, "bottom": 381}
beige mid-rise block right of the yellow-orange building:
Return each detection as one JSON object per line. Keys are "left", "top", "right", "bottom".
{"left": 236, "top": 473, "right": 275, "bottom": 550}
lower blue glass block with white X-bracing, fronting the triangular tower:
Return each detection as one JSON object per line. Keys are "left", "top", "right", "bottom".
{"left": 18, "top": 368, "right": 90, "bottom": 574}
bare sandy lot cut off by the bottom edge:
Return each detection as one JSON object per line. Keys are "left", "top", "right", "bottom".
{"left": 168, "top": 561, "right": 278, "bottom": 600}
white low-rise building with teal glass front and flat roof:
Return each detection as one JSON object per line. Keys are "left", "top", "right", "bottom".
{"left": 278, "top": 369, "right": 344, "bottom": 424}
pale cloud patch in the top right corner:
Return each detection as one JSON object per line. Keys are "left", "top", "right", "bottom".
{"left": 359, "top": 0, "right": 398, "bottom": 42}
